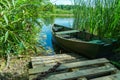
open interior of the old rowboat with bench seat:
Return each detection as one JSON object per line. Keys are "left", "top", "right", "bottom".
{"left": 53, "top": 26, "right": 115, "bottom": 44}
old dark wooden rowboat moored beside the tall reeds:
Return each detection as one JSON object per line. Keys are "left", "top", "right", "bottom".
{"left": 52, "top": 24, "right": 116, "bottom": 58}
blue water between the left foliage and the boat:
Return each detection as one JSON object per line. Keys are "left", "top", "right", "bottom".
{"left": 40, "top": 18, "right": 74, "bottom": 51}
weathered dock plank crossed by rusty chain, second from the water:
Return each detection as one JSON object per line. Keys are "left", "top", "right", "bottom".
{"left": 29, "top": 58, "right": 109, "bottom": 74}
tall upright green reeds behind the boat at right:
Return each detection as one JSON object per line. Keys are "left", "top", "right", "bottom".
{"left": 74, "top": 0, "right": 120, "bottom": 39}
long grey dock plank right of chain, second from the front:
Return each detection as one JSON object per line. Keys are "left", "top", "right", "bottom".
{"left": 45, "top": 66, "right": 116, "bottom": 80}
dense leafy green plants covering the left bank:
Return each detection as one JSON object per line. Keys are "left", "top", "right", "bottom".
{"left": 0, "top": 0, "right": 46, "bottom": 56}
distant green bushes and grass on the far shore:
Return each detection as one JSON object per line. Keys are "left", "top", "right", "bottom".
{"left": 33, "top": 1, "right": 73, "bottom": 17}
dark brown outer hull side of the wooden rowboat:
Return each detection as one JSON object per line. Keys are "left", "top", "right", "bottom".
{"left": 52, "top": 23, "right": 114, "bottom": 58}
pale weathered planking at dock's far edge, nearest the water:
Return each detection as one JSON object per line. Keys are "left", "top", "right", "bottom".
{"left": 31, "top": 54, "right": 79, "bottom": 68}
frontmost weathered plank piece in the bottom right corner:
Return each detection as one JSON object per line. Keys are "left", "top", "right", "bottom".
{"left": 90, "top": 73, "right": 120, "bottom": 80}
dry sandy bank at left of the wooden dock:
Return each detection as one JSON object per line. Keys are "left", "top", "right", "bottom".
{"left": 0, "top": 55, "right": 30, "bottom": 80}
